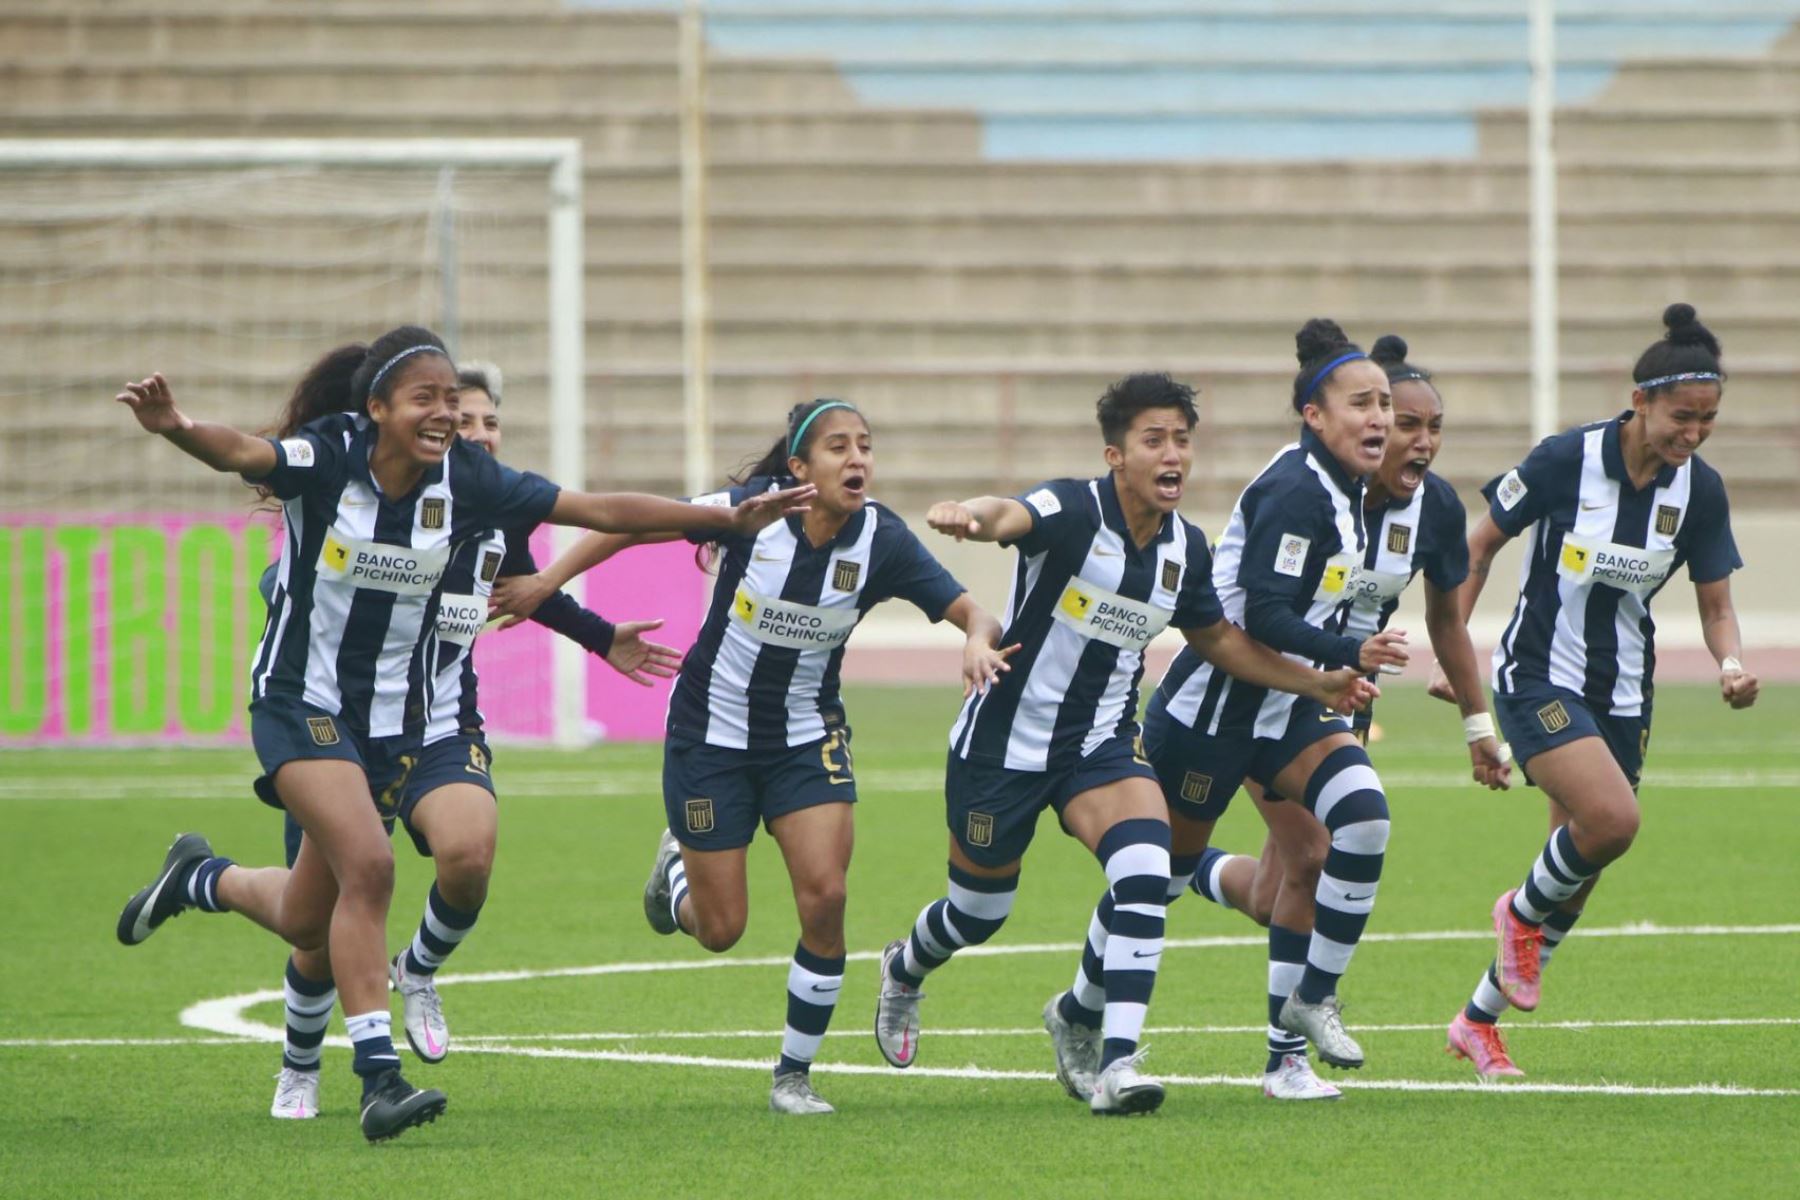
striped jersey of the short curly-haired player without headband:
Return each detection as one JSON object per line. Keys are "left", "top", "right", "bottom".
{"left": 950, "top": 475, "right": 1224, "bottom": 772}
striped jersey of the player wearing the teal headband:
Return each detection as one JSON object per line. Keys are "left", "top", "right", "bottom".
{"left": 668, "top": 477, "right": 963, "bottom": 750}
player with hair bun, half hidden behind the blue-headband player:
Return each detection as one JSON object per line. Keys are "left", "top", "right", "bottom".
{"left": 1193, "top": 335, "right": 1510, "bottom": 1099}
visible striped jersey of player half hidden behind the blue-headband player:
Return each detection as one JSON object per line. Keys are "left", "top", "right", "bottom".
{"left": 1345, "top": 473, "right": 1469, "bottom": 640}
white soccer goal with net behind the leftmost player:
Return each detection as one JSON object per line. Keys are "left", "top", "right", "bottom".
{"left": 0, "top": 139, "right": 587, "bottom": 747}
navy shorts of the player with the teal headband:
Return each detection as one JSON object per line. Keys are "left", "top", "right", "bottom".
{"left": 662, "top": 727, "right": 857, "bottom": 849}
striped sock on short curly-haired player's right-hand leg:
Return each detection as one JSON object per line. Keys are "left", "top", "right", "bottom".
{"left": 1094, "top": 819, "right": 1168, "bottom": 1070}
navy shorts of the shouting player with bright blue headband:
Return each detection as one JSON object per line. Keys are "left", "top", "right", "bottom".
{"left": 1143, "top": 693, "right": 1355, "bottom": 820}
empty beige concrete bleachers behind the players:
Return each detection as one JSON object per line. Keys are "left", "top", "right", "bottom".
{"left": 0, "top": 0, "right": 1800, "bottom": 511}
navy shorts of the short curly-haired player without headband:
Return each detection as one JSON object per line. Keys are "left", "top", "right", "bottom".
{"left": 943, "top": 736, "right": 1156, "bottom": 867}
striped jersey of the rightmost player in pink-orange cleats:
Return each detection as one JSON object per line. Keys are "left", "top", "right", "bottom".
{"left": 1485, "top": 410, "right": 1744, "bottom": 716}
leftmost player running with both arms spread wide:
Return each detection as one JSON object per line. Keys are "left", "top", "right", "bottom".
{"left": 117, "top": 326, "right": 806, "bottom": 1141}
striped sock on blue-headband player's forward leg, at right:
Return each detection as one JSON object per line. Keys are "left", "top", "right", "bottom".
{"left": 1294, "top": 745, "right": 1388, "bottom": 1004}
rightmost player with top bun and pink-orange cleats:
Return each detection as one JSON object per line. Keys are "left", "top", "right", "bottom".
{"left": 1449, "top": 304, "right": 1757, "bottom": 1079}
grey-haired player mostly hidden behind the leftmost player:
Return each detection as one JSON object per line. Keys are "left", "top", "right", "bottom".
{"left": 265, "top": 362, "right": 680, "bottom": 1119}
